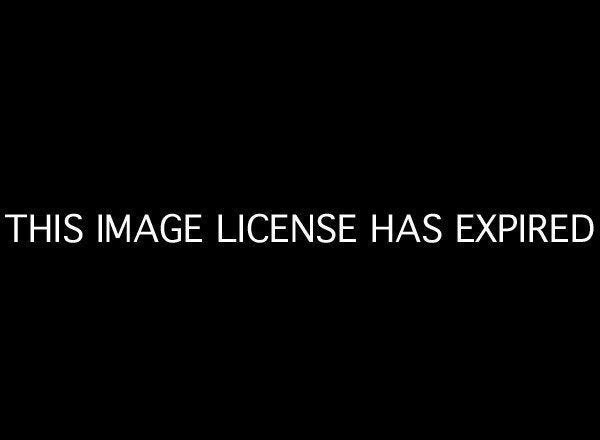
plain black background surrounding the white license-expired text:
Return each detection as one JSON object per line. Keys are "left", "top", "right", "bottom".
{"left": 1, "top": 5, "right": 598, "bottom": 433}
